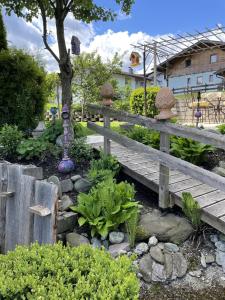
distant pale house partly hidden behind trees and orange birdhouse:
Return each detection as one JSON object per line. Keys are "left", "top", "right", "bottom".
{"left": 113, "top": 68, "right": 151, "bottom": 89}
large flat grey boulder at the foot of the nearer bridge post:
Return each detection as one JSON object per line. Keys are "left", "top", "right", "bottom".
{"left": 136, "top": 210, "right": 193, "bottom": 244}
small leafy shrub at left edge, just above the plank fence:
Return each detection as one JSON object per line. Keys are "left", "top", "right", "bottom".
{"left": 0, "top": 124, "right": 23, "bottom": 159}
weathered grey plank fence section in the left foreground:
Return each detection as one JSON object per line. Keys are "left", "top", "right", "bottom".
{"left": 0, "top": 162, "right": 58, "bottom": 253}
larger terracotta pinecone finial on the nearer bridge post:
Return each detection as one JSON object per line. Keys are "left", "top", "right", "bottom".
{"left": 155, "top": 87, "right": 176, "bottom": 120}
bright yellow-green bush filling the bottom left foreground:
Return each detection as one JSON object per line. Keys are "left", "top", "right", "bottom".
{"left": 0, "top": 244, "right": 140, "bottom": 300}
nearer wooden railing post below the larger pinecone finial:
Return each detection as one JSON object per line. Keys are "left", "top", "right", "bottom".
{"left": 159, "top": 132, "right": 170, "bottom": 209}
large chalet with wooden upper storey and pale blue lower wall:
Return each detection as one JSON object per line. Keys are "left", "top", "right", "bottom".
{"left": 149, "top": 40, "right": 225, "bottom": 89}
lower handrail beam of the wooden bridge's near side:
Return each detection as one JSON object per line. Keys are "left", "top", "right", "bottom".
{"left": 88, "top": 123, "right": 225, "bottom": 195}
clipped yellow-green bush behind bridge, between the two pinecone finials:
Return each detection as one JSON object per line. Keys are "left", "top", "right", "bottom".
{"left": 130, "top": 87, "right": 159, "bottom": 118}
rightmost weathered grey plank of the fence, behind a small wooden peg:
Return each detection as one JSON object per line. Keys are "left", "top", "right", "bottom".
{"left": 33, "top": 181, "right": 58, "bottom": 244}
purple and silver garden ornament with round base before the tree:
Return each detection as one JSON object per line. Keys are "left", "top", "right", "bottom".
{"left": 58, "top": 104, "right": 75, "bottom": 174}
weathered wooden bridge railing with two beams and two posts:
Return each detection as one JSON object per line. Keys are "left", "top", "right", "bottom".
{"left": 88, "top": 104, "right": 225, "bottom": 208}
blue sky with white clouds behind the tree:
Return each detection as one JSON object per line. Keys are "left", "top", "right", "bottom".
{"left": 3, "top": 0, "right": 225, "bottom": 72}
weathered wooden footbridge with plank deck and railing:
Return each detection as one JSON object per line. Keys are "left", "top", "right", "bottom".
{"left": 88, "top": 105, "right": 225, "bottom": 234}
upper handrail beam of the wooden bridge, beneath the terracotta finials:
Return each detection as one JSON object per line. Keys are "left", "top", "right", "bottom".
{"left": 88, "top": 104, "right": 225, "bottom": 149}
